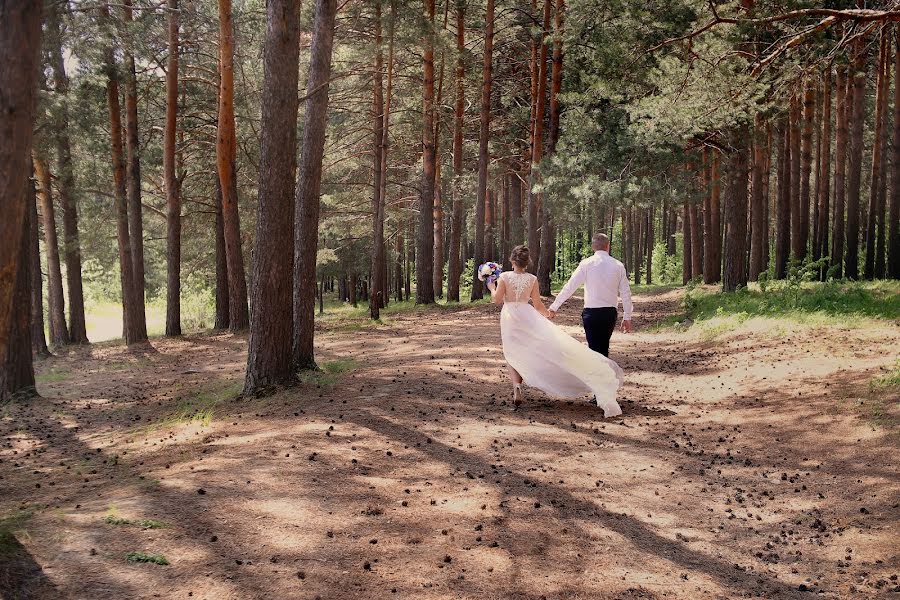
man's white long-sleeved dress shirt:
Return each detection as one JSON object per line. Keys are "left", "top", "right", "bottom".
{"left": 550, "top": 250, "right": 631, "bottom": 321}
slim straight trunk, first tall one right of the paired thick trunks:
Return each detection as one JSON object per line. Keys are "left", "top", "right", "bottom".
{"left": 369, "top": 0, "right": 385, "bottom": 319}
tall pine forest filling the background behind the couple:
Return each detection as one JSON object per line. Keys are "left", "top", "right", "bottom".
{"left": 0, "top": 0, "right": 900, "bottom": 404}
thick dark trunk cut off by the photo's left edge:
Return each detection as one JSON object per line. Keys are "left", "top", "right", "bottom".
{"left": 0, "top": 0, "right": 42, "bottom": 380}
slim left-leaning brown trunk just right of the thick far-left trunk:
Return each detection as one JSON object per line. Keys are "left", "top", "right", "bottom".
{"left": 34, "top": 153, "right": 69, "bottom": 348}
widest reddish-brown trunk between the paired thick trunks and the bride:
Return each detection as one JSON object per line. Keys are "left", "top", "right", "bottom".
{"left": 416, "top": 0, "right": 440, "bottom": 304}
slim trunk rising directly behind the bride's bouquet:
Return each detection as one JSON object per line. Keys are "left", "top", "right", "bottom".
{"left": 471, "top": 0, "right": 494, "bottom": 300}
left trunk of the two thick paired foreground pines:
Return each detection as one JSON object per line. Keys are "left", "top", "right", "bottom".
{"left": 244, "top": 0, "right": 300, "bottom": 395}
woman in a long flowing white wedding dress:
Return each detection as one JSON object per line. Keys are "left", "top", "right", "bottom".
{"left": 488, "top": 246, "right": 622, "bottom": 417}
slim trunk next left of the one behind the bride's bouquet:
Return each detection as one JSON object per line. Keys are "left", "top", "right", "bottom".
{"left": 447, "top": 0, "right": 466, "bottom": 302}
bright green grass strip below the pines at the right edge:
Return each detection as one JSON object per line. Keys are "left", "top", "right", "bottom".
{"left": 676, "top": 280, "right": 900, "bottom": 328}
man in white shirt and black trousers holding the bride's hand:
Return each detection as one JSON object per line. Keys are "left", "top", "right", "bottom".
{"left": 549, "top": 233, "right": 631, "bottom": 357}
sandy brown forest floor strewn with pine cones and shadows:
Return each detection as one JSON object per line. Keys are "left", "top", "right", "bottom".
{"left": 0, "top": 290, "right": 900, "bottom": 600}
